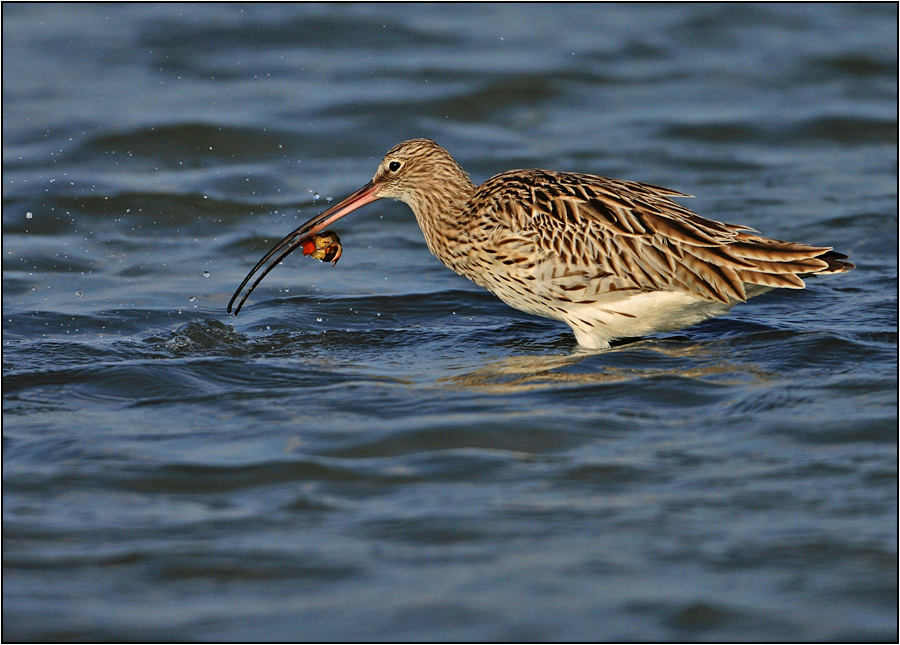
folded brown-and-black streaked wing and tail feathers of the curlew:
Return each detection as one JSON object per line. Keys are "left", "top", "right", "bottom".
{"left": 467, "top": 170, "right": 853, "bottom": 304}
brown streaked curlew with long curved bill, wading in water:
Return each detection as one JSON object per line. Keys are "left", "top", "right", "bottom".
{"left": 228, "top": 139, "right": 854, "bottom": 349}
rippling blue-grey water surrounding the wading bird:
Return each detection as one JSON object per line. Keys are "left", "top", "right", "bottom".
{"left": 2, "top": 4, "right": 898, "bottom": 641}
